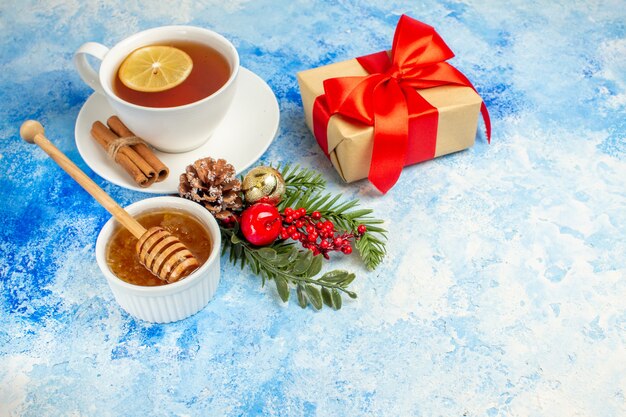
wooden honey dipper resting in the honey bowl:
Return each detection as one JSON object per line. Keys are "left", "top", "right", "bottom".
{"left": 20, "top": 120, "right": 199, "bottom": 282}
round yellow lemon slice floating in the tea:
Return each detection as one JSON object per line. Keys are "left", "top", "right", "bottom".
{"left": 118, "top": 45, "right": 193, "bottom": 93}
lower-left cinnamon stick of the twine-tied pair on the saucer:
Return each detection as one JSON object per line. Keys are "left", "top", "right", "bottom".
{"left": 91, "top": 121, "right": 156, "bottom": 188}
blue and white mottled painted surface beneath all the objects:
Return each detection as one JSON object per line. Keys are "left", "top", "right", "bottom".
{"left": 0, "top": 0, "right": 626, "bottom": 417}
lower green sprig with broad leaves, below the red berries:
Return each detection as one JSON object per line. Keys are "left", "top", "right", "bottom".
{"left": 220, "top": 227, "right": 357, "bottom": 310}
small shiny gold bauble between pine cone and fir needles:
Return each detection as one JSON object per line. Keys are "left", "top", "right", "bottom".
{"left": 241, "top": 166, "right": 285, "bottom": 205}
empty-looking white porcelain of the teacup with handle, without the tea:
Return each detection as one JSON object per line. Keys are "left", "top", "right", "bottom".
{"left": 74, "top": 26, "right": 239, "bottom": 153}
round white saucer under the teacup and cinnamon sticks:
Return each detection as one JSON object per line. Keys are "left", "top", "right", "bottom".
{"left": 74, "top": 67, "right": 280, "bottom": 194}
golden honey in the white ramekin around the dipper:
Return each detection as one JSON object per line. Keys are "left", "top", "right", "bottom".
{"left": 106, "top": 210, "right": 213, "bottom": 287}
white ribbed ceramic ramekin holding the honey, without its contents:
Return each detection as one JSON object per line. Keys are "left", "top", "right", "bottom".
{"left": 96, "top": 197, "right": 221, "bottom": 323}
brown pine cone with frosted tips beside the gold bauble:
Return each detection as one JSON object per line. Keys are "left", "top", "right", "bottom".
{"left": 178, "top": 158, "right": 243, "bottom": 221}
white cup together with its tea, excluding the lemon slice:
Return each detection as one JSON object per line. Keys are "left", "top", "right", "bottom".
{"left": 74, "top": 26, "right": 239, "bottom": 153}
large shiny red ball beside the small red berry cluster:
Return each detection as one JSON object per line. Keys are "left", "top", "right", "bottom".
{"left": 241, "top": 203, "right": 283, "bottom": 246}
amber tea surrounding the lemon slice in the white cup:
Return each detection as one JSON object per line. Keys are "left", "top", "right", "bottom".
{"left": 113, "top": 41, "right": 231, "bottom": 107}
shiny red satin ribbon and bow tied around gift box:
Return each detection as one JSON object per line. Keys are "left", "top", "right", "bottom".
{"left": 313, "top": 15, "right": 491, "bottom": 193}
